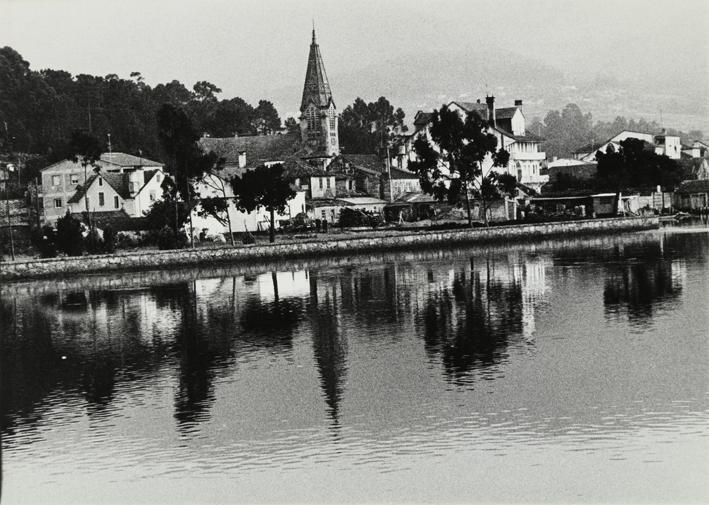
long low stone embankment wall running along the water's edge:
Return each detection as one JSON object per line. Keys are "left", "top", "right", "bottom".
{"left": 0, "top": 217, "right": 659, "bottom": 281}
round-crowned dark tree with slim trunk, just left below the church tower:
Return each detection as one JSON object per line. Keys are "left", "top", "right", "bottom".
{"left": 231, "top": 164, "right": 295, "bottom": 242}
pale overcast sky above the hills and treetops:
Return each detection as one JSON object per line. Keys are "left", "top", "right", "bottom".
{"left": 0, "top": 0, "right": 709, "bottom": 119}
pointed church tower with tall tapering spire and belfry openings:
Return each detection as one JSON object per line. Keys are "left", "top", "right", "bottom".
{"left": 300, "top": 28, "right": 340, "bottom": 158}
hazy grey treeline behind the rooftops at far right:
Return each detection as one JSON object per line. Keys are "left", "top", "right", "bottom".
{"left": 527, "top": 103, "right": 703, "bottom": 160}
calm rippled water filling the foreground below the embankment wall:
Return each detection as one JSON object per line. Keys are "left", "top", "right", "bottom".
{"left": 0, "top": 225, "right": 709, "bottom": 504}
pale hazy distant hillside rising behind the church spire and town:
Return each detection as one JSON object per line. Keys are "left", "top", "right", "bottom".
{"left": 264, "top": 49, "right": 709, "bottom": 132}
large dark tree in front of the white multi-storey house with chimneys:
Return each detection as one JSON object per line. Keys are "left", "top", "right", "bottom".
{"left": 409, "top": 105, "right": 516, "bottom": 226}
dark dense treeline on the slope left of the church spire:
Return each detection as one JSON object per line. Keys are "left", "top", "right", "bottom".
{"left": 0, "top": 47, "right": 281, "bottom": 168}
